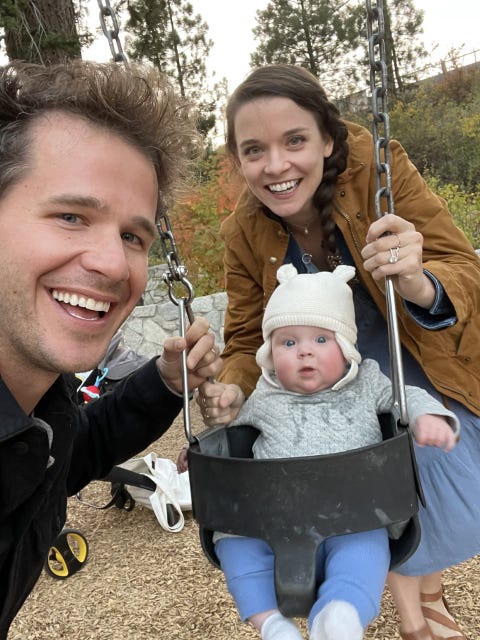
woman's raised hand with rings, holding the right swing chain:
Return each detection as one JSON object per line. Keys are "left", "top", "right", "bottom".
{"left": 362, "top": 214, "right": 435, "bottom": 309}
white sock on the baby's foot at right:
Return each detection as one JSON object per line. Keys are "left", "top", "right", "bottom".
{"left": 310, "top": 600, "right": 363, "bottom": 640}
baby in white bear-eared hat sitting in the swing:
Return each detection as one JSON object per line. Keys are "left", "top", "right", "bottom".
{"left": 214, "top": 264, "right": 460, "bottom": 640}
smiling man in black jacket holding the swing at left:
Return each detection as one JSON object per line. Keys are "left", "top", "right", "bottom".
{"left": 0, "top": 61, "right": 221, "bottom": 639}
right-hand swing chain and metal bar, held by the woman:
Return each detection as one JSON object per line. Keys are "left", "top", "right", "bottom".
{"left": 365, "top": 0, "right": 408, "bottom": 425}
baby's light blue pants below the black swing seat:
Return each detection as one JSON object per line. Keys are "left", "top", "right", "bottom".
{"left": 215, "top": 529, "right": 390, "bottom": 628}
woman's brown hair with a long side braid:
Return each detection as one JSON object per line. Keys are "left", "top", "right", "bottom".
{"left": 226, "top": 64, "right": 348, "bottom": 253}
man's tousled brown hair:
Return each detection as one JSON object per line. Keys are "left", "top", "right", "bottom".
{"left": 0, "top": 60, "right": 200, "bottom": 205}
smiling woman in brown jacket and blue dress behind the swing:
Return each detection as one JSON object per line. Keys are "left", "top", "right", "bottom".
{"left": 196, "top": 65, "right": 480, "bottom": 640}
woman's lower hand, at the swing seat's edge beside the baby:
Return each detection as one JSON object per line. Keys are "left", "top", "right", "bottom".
{"left": 197, "top": 382, "right": 245, "bottom": 427}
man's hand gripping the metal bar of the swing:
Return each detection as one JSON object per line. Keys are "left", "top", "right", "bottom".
{"left": 157, "top": 317, "right": 223, "bottom": 393}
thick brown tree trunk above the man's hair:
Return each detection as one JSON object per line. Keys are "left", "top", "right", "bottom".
{"left": 0, "top": 0, "right": 91, "bottom": 64}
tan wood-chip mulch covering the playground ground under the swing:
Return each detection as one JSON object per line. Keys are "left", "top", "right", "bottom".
{"left": 8, "top": 403, "right": 480, "bottom": 640}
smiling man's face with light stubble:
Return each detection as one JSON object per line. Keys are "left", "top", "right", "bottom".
{"left": 0, "top": 113, "right": 157, "bottom": 392}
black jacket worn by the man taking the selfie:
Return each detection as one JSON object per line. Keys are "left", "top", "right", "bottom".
{"left": 0, "top": 360, "right": 183, "bottom": 640}
